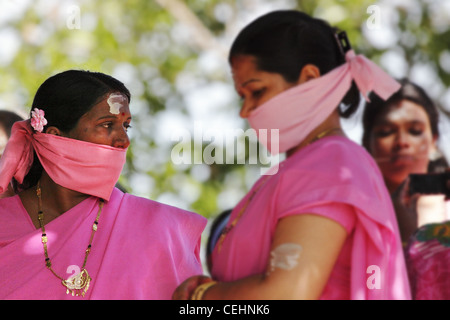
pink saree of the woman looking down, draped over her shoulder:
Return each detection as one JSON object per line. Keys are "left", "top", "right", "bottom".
{"left": 212, "top": 137, "right": 411, "bottom": 300}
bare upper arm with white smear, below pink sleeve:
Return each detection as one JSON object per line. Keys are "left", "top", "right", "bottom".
{"left": 264, "top": 213, "right": 347, "bottom": 299}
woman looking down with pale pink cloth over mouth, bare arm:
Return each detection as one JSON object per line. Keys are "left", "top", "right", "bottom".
{"left": 173, "top": 11, "right": 411, "bottom": 300}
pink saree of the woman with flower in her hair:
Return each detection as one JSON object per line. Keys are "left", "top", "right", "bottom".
{"left": 0, "top": 189, "right": 206, "bottom": 300}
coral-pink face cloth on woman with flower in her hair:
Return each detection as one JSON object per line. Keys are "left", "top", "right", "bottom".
{"left": 0, "top": 120, "right": 127, "bottom": 200}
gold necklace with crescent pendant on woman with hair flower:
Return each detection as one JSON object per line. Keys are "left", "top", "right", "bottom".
{"left": 36, "top": 182, "right": 105, "bottom": 297}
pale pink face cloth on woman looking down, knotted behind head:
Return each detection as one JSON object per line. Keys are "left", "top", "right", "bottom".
{"left": 248, "top": 50, "right": 400, "bottom": 155}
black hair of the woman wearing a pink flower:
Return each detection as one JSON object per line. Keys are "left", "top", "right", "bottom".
{"left": 16, "top": 70, "right": 131, "bottom": 191}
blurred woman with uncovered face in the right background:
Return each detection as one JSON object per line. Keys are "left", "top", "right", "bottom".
{"left": 363, "top": 79, "right": 450, "bottom": 300}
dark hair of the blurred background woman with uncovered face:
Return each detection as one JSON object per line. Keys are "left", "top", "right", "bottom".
{"left": 362, "top": 78, "right": 448, "bottom": 172}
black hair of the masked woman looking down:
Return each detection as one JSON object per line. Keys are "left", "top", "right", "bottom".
{"left": 228, "top": 10, "right": 360, "bottom": 118}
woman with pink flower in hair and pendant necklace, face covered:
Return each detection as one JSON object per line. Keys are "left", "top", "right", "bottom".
{"left": 0, "top": 70, "right": 206, "bottom": 299}
